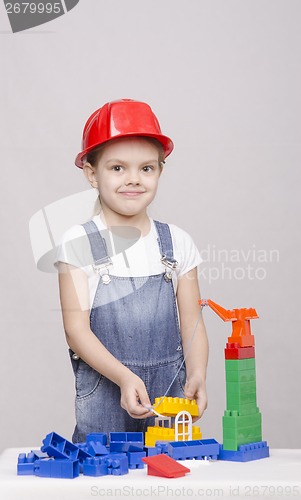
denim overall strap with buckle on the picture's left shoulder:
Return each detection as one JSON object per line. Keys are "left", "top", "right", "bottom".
{"left": 82, "top": 220, "right": 112, "bottom": 284}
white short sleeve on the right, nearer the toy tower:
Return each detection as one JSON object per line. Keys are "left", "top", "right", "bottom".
{"left": 169, "top": 224, "right": 202, "bottom": 277}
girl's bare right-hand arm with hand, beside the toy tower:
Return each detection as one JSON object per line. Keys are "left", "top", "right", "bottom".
{"left": 177, "top": 268, "right": 208, "bottom": 420}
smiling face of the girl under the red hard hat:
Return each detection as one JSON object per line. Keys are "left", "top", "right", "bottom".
{"left": 88, "top": 138, "right": 161, "bottom": 216}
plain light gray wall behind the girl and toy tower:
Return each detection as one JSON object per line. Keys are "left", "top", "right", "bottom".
{"left": 0, "top": 0, "right": 301, "bottom": 449}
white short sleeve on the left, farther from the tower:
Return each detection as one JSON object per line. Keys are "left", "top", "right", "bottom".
{"left": 54, "top": 225, "right": 93, "bottom": 269}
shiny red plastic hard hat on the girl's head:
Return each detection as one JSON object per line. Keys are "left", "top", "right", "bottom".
{"left": 75, "top": 99, "right": 173, "bottom": 168}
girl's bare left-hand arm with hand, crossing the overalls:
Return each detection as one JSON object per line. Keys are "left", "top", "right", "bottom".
{"left": 59, "top": 262, "right": 153, "bottom": 418}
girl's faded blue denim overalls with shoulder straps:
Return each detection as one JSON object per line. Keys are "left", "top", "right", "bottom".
{"left": 70, "top": 221, "right": 186, "bottom": 442}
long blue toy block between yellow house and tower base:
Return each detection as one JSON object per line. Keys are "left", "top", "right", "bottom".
{"left": 168, "top": 439, "right": 220, "bottom": 460}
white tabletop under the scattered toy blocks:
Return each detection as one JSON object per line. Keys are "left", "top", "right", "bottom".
{"left": 0, "top": 447, "right": 301, "bottom": 500}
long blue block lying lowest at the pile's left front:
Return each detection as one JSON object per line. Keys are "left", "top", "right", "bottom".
{"left": 34, "top": 458, "right": 79, "bottom": 479}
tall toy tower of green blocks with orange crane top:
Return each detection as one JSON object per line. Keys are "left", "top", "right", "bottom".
{"left": 201, "top": 299, "right": 269, "bottom": 461}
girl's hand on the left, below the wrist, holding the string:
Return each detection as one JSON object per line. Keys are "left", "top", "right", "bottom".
{"left": 120, "top": 372, "right": 154, "bottom": 418}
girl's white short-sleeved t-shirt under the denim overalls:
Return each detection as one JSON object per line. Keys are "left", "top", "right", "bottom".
{"left": 55, "top": 215, "right": 202, "bottom": 306}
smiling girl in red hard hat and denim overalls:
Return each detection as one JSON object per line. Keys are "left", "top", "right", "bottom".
{"left": 57, "top": 99, "right": 208, "bottom": 442}
